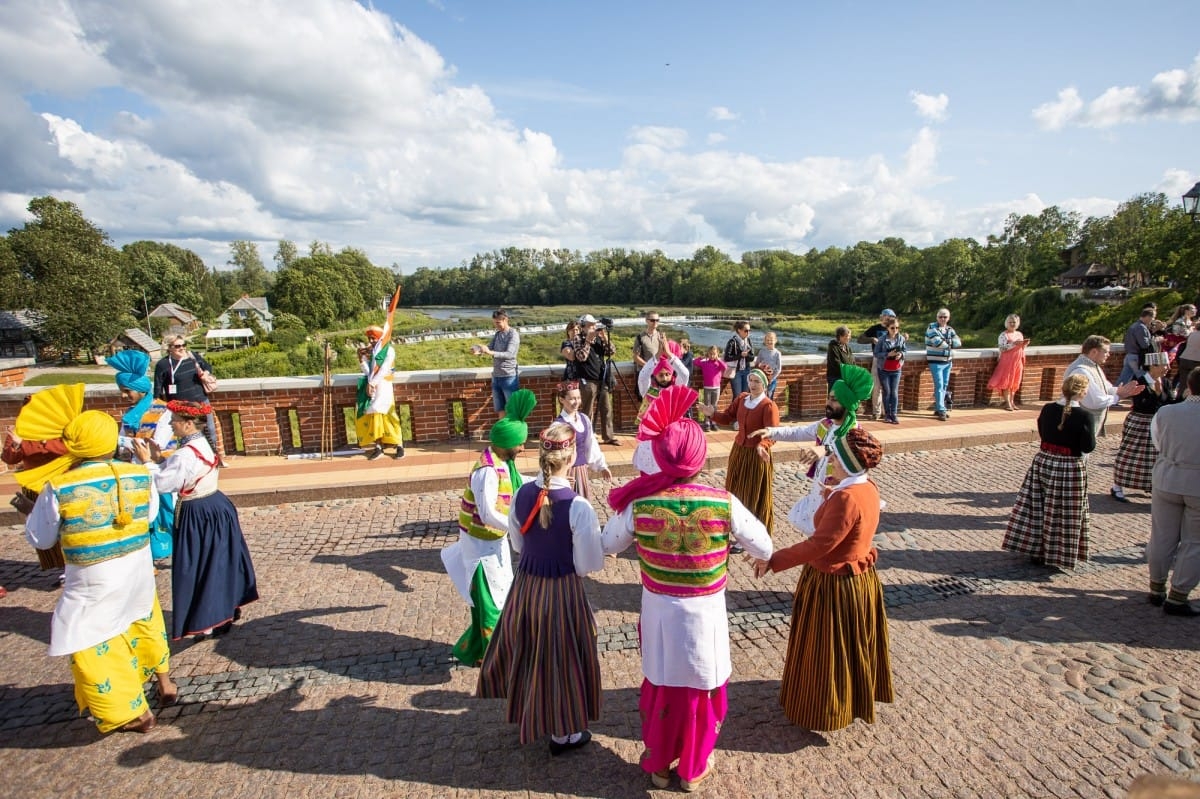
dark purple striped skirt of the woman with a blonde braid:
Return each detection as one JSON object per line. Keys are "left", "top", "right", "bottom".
{"left": 475, "top": 570, "right": 600, "bottom": 744}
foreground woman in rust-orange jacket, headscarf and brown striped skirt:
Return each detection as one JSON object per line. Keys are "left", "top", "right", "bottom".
{"left": 755, "top": 427, "right": 894, "bottom": 731}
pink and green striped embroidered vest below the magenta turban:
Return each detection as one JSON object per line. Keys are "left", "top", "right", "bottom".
{"left": 634, "top": 483, "right": 732, "bottom": 597}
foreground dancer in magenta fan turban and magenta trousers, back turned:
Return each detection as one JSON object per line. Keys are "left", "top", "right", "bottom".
{"left": 604, "top": 386, "right": 772, "bottom": 791}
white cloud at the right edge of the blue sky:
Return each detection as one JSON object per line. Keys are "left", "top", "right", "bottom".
{"left": 1033, "top": 55, "right": 1200, "bottom": 131}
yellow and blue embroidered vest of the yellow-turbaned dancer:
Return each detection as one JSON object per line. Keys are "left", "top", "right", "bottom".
{"left": 49, "top": 461, "right": 150, "bottom": 566}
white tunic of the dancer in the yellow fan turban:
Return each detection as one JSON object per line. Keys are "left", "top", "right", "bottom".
{"left": 25, "top": 472, "right": 158, "bottom": 656}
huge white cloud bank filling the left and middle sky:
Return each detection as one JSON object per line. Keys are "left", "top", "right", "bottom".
{"left": 0, "top": 0, "right": 1118, "bottom": 270}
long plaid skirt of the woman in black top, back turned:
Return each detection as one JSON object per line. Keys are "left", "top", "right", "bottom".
{"left": 1001, "top": 450, "right": 1090, "bottom": 569}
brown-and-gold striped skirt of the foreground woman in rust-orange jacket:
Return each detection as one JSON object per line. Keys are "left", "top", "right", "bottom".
{"left": 779, "top": 566, "right": 894, "bottom": 731}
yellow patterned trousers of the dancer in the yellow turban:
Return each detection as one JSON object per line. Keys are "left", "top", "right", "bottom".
{"left": 71, "top": 594, "right": 170, "bottom": 733}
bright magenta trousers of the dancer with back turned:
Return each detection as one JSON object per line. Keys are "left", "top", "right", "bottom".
{"left": 637, "top": 679, "right": 728, "bottom": 780}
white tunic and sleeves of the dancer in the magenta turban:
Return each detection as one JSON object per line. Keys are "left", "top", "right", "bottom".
{"left": 602, "top": 494, "right": 774, "bottom": 691}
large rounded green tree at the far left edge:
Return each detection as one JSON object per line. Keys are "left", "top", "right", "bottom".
{"left": 8, "top": 197, "right": 133, "bottom": 350}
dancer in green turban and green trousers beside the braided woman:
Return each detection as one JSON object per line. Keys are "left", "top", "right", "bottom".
{"left": 442, "top": 389, "right": 538, "bottom": 666}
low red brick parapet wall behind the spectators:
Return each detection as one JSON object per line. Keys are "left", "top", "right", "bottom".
{"left": 0, "top": 347, "right": 1121, "bottom": 455}
